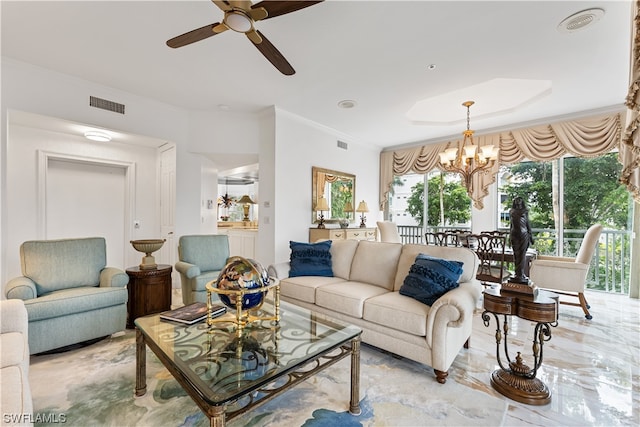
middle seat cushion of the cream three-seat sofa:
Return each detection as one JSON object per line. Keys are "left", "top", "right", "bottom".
{"left": 316, "top": 281, "right": 388, "bottom": 318}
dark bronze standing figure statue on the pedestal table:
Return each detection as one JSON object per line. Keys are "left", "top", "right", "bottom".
{"left": 509, "top": 197, "right": 533, "bottom": 284}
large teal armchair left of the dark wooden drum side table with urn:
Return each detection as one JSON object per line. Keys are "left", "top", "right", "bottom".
{"left": 5, "top": 237, "right": 129, "bottom": 354}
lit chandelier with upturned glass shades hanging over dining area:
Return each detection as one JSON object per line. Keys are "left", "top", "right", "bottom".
{"left": 439, "top": 101, "right": 498, "bottom": 196}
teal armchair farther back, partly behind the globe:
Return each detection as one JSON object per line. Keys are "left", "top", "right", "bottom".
{"left": 175, "top": 234, "right": 229, "bottom": 304}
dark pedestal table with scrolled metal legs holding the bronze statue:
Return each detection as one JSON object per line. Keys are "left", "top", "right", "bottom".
{"left": 482, "top": 289, "right": 558, "bottom": 405}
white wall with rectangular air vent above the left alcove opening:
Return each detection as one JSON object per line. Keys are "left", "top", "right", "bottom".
{"left": 0, "top": 57, "right": 202, "bottom": 286}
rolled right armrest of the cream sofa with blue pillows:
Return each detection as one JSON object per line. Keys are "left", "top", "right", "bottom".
{"left": 427, "top": 280, "right": 482, "bottom": 348}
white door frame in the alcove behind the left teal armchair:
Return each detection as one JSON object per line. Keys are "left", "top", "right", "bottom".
{"left": 36, "top": 150, "right": 136, "bottom": 262}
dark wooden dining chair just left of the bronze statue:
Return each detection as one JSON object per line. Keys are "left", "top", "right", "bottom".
{"left": 466, "top": 233, "right": 511, "bottom": 286}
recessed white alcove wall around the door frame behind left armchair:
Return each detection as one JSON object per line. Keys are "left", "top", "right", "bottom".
{"left": 3, "top": 124, "right": 159, "bottom": 278}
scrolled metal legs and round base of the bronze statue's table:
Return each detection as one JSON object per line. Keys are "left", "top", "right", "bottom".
{"left": 482, "top": 311, "right": 551, "bottom": 405}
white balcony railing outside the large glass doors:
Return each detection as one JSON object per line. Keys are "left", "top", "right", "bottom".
{"left": 398, "top": 225, "right": 632, "bottom": 295}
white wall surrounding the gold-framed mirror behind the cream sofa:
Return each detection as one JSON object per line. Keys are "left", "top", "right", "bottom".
{"left": 270, "top": 109, "right": 382, "bottom": 262}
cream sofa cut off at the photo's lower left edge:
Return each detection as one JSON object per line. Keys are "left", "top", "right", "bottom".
{"left": 0, "top": 300, "right": 33, "bottom": 426}
